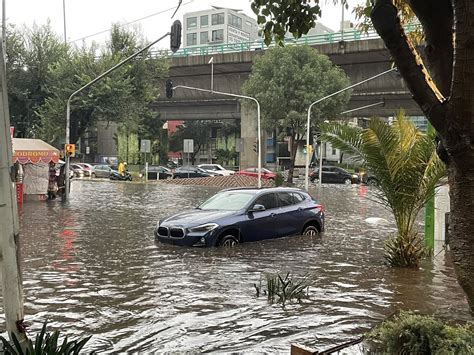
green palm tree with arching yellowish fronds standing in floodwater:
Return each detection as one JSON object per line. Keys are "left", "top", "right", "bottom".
{"left": 321, "top": 110, "right": 446, "bottom": 266}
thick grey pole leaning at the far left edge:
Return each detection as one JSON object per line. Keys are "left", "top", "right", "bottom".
{"left": 0, "top": 29, "right": 26, "bottom": 344}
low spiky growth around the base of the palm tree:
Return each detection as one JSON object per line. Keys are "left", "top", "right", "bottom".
{"left": 384, "top": 232, "right": 429, "bottom": 267}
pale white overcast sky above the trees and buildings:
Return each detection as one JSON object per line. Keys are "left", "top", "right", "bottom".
{"left": 6, "top": 0, "right": 360, "bottom": 48}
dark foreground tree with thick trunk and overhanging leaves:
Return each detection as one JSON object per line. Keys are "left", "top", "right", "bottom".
{"left": 252, "top": 0, "right": 474, "bottom": 311}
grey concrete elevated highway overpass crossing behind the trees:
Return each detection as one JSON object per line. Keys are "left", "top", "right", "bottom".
{"left": 154, "top": 34, "right": 422, "bottom": 166}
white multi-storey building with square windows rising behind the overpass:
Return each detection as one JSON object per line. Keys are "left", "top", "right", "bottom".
{"left": 183, "top": 6, "right": 258, "bottom": 48}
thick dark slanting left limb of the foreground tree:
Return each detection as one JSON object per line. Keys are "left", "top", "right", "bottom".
{"left": 370, "top": 0, "right": 447, "bottom": 132}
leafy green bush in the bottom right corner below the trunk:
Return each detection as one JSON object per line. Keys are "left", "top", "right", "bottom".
{"left": 367, "top": 312, "right": 474, "bottom": 355}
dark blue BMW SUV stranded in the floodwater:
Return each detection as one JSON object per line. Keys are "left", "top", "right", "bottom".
{"left": 155, "top": 187, "right": 324, "bottom": 246}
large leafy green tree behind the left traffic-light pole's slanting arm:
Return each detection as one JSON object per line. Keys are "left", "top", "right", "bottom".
{"left": 38, "top": 26, "right": 169, "bottom": 146}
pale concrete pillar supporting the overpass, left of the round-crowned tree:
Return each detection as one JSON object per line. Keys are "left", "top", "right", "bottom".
{"left": 240, "top": 103, "right": 265, "bottom": 169}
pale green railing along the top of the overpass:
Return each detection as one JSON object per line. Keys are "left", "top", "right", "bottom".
{"left": 151, "top": 24, "right": 420, "bottom": 57}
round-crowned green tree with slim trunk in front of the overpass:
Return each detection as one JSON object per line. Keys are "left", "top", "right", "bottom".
{"left": 242, "top": 46, "right": 350, "bottom": 183}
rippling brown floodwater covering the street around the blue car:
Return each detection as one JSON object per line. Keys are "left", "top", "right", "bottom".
{"left": 0, "top": 180, "right": 471, "bottom": 353}
